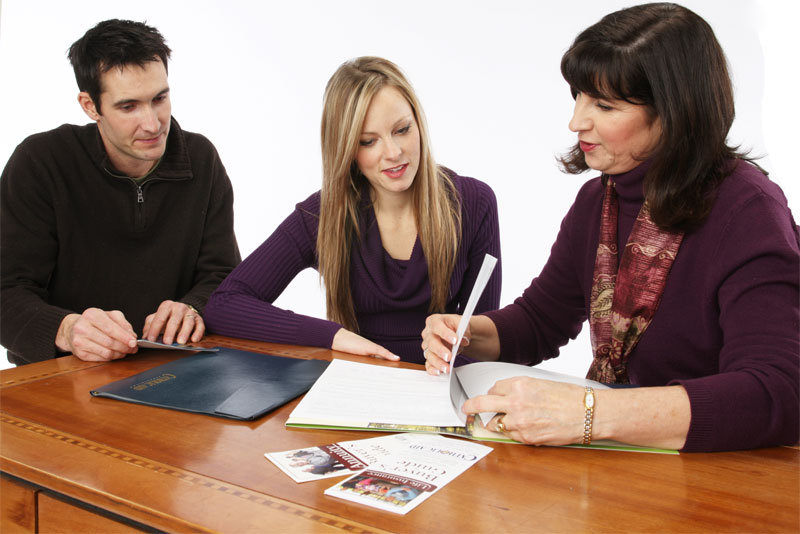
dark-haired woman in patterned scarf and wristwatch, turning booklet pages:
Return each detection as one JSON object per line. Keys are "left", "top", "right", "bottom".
{"left": 422, "top": 4, "right": 800, "bottom": 451}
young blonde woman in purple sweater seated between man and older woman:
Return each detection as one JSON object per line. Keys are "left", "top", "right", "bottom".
{"left": 204, "top": 57, "right": 500, "bottom": 363}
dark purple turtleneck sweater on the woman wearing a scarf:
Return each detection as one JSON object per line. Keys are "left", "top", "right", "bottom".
{"left": 486, "top": 161, "right": 800, "bottom": 451}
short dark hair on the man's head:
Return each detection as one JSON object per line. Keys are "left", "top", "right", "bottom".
{"left": 67, "top": 19, "right": 172, "bottom": 113}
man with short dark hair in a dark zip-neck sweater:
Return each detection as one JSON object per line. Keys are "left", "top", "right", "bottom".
{"left": 0, "top": 20, "right": 240, "bottom": 364}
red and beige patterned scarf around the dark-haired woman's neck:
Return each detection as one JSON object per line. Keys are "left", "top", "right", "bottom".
{"left": 586, "top": 177, "right": 683, "bottom": 384}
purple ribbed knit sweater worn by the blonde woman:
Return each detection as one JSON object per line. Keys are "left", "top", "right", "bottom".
{"left": 203, "top": 175, "right": 501, "bottom": 363}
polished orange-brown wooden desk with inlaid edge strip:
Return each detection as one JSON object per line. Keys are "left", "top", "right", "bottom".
{"left": 0, "top": 336, "right": 800, "bottom": 533}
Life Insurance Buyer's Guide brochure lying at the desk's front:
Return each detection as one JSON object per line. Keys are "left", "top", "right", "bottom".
{"left": 325, "top": 434, "right": 492, "bottom": 514}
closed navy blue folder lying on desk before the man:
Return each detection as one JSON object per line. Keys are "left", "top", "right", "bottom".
{"left": 90, "top": 348, "right": 330, "bottom": 420}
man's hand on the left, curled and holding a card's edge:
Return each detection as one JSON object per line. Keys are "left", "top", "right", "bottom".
{"left": 56, "top": 308, "right": 138, "bottom": 362}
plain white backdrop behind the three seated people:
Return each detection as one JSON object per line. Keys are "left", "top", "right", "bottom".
{"left": 0, "top": 0, "right": 800, "bottom": 375}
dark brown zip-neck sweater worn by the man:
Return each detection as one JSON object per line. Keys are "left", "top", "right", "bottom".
{"left": 0, "top": 119, "right": 240, "bottom": 364}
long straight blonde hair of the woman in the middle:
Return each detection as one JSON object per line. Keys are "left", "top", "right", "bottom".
{"left": 317, "top": 57, "right": 461, "bottom": 332}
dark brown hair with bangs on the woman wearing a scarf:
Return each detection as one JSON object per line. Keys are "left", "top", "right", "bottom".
{"left": 559, "top": 3, "right": 746, "bottom": 230}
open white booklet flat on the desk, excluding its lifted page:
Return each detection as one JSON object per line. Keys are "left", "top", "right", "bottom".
{"left": 286, "top": 359, "right": 677, "bottom": 454}
